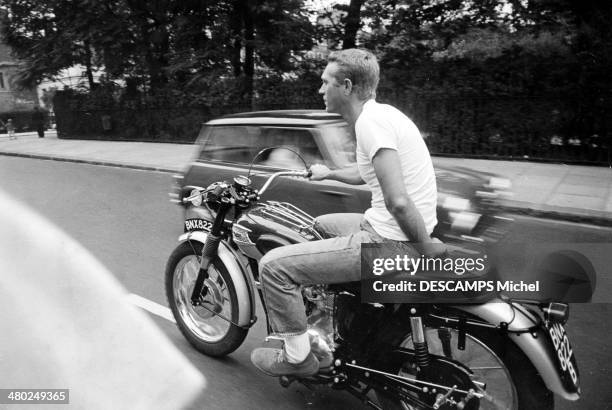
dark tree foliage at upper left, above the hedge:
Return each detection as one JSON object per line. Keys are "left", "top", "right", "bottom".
{"left": 1, "top": 0, "right": 314, "bottom": 102}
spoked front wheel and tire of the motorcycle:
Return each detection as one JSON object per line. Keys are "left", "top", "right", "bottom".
{"left": 166, "top": 241, "right": 248, "bottom": 357}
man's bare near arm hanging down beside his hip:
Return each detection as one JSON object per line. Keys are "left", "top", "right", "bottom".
{"left": 372, "top": 148, "right": 444, "bottom": 256}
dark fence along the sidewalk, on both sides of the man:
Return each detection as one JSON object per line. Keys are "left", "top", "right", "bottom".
{"left": 56, "top": 94, "right": 612, "bottom": 165}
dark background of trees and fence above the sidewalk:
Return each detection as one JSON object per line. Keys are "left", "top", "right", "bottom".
{"left": 0, "top": 0, "right": 612, "bottom": 164}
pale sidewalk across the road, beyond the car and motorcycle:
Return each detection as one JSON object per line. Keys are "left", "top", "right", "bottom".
{"left": 0, "top": 131, "right": 612, "bottom": 225}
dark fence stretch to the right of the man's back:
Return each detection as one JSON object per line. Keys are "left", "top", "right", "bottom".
{"left": 380, "top": 93, "right": 612, "bottom": 165}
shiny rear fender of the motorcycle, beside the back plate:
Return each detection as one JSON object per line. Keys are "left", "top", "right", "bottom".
{"left": 453, "top": 300, "right": 580, "bottom": 401}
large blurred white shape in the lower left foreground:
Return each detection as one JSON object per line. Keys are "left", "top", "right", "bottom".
{"left": 0, "top": 191, "right": 205, "bottom": 410}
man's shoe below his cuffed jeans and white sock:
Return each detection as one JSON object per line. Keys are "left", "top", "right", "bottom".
{"left": 251, "top": 347, "right": 319, "bottom": 377}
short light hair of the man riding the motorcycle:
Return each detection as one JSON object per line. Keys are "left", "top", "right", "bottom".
{"left": 327, "top": 48, "right": 380, "bottom": 100}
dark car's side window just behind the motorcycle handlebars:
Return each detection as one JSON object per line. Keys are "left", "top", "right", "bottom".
{"left": 200, "top": 126, "right": 322, "bottom": 169}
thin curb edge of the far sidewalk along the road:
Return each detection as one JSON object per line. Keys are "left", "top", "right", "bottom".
{"left": 0, "top": 151, "right": 612, "bottom": 227}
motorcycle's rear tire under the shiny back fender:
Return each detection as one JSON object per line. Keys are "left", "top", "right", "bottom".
{"left": 376, "top": 328, "right": 554, "bottom": 410}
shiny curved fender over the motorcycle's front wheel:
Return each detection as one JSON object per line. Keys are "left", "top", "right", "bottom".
{"left": 179, "top": 231, "right": 256, "bottom": 327}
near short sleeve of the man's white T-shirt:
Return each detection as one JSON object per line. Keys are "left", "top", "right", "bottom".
{"left": 355, "top": 109, "right": 398, "bottom": 162}
